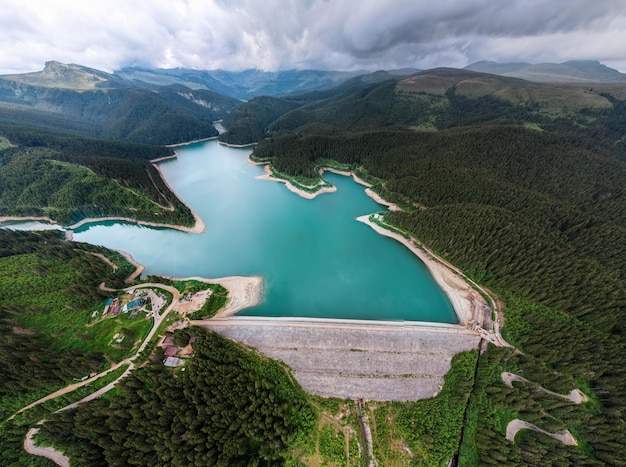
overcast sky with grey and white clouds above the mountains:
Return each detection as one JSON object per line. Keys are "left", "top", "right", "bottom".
{"left": 0, "top": 0, "right": 626, "bottom": 73}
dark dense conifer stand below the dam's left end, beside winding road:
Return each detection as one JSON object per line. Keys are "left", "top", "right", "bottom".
{"left": 37, "top": 330, "right": 314, "bottom": 466}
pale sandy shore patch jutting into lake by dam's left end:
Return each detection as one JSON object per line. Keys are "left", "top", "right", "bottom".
{"left": 163, "top": 276, "right": 263, "bottom": 318}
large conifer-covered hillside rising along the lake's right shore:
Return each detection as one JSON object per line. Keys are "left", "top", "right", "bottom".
{"left": 224, "top": 70, "right": 626, "bottom": 465}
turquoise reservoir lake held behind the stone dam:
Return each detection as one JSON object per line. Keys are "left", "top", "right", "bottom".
{"left": 9, "top": 141, "right": 458, "bottom": 323}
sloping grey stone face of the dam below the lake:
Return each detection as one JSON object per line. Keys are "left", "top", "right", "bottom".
{"left": 200, "top": 318, "right": 480, "bottom": 401}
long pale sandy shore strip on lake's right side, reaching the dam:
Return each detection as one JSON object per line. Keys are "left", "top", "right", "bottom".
{"left": 357, "top": 216, "right": 487, "bottom": 325}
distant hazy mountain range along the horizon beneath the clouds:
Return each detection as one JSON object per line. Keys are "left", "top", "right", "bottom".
{"left": 0, "top": 61, "right": 626, "bottom": 144}
